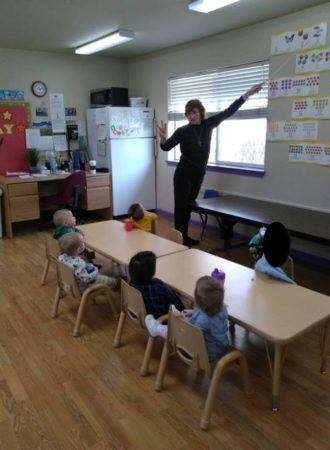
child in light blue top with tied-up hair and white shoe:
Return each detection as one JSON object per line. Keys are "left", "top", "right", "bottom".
{"left": 145, "top": 276, "right": 229, "bottom": 361}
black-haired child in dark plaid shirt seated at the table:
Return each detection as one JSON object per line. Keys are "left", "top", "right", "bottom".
{"left": 128, "top": 251, "right": 183, "bottom": 319}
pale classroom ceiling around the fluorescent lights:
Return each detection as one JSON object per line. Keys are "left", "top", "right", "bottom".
{"left": 0, "top": 0, "right": 327, "bottom": 58}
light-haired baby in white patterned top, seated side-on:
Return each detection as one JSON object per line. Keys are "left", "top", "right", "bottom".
{"left": 58, "top": 232, "right": 121, "bottom": 293}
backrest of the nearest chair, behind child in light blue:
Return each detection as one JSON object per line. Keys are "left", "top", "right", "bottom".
{"left": 167, "top": 313, "right": 212, "bottom": 375}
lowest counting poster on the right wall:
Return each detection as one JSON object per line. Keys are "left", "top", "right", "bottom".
{"left": 289, "top": 142, "right": 330, "bottom": 165}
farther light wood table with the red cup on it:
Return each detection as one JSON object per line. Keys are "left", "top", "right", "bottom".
{"left": 79, "top": 220, "right": 187, "bottom": 264}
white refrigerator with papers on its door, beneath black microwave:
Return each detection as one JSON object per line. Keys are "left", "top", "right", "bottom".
{"left": 87, "top": 106, "right": 156, "bottom": 216}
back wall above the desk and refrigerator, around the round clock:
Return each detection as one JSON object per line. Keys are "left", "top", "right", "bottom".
{"left": 0, "top": 48, "right": 128, "bottom": 121}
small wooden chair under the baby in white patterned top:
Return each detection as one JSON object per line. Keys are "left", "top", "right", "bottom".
{"left": 51, "top": 261, "right": 118, "bottom": 337}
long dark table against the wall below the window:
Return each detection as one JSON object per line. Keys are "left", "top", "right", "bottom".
{"left": 191, "top": 194, "right": 330, "bottom": 246}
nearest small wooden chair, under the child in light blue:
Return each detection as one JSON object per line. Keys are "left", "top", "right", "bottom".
{"left": 155, "top": 313, "right": 254, "bottom": 430}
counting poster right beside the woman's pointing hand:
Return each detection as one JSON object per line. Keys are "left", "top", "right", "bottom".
{"left": 269, "top": 73, "right": 320, "bottom": 98}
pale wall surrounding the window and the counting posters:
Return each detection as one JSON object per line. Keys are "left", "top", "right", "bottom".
{"left": 129, "top": 3, "right": 330, "bottom": 216}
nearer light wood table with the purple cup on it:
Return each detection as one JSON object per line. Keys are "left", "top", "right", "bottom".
{"left": 156, "top": 250, "right": 330, "bottom": 410}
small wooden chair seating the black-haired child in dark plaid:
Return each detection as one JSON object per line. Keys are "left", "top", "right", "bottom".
{"left": 113, "top": 280, "right": 167, "bottom": 376}
